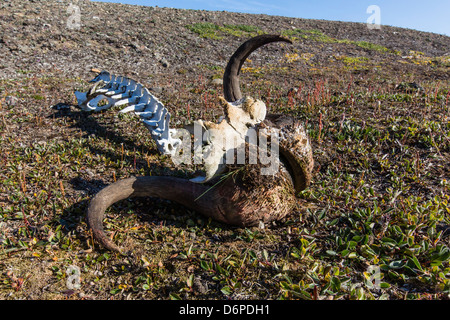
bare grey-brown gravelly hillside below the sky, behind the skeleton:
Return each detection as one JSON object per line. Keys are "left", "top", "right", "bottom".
{"left": 0, "top": 0, "right": 450, "bottom": 81}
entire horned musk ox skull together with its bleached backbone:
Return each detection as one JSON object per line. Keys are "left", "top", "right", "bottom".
{"left": 75, "top": 35, "right": 313, "bottom": 252}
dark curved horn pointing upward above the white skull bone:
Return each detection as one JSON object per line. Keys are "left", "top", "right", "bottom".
{"left": 223, "top": 34, "right": 292, "bottom": 102}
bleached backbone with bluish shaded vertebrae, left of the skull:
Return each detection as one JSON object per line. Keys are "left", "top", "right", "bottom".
{"left": 75, "top": 71, "right": 181, "bottom": 155}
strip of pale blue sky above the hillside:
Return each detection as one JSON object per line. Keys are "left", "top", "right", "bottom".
{"left": 93, "top": 0, "right": 450, "bottom": 36}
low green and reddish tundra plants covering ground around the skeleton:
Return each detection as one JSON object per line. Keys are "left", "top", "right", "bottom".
{"left": 0, "top": 0, "right": 450, "bottom": 299}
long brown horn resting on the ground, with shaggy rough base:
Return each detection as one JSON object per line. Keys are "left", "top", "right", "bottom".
{"left": 87, "top": 165, "right": 296, "bottom": 252}
